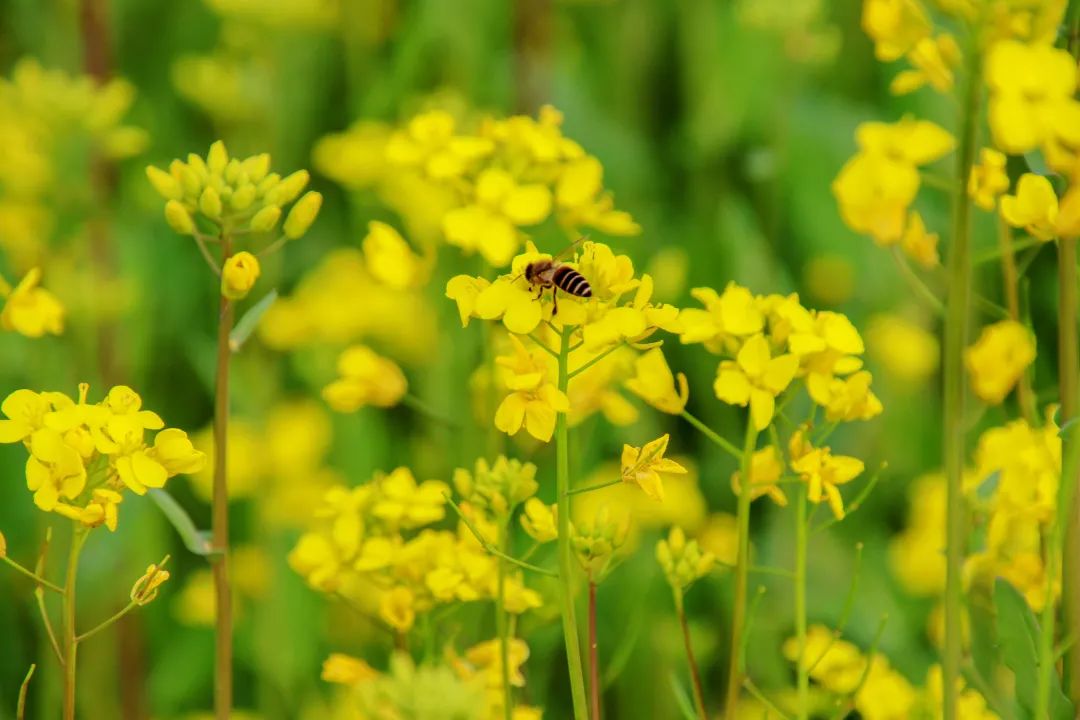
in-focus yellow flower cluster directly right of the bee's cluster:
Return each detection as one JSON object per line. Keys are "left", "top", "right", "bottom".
{"left": 678, "top": 283, "right": 881, "bottom": 431}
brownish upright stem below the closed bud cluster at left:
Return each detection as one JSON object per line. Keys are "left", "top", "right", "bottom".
{"left": 211, "top": 234, "right": 234, "bottom": 720}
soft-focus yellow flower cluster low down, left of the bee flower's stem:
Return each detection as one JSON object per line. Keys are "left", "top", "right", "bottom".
{"left": 288, "top": 459, "right": 541, "bottom": 633}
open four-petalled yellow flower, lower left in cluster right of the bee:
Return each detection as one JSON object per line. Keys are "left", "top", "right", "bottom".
{"left": 713, "top": 335, "right": 799, "bottom": 431}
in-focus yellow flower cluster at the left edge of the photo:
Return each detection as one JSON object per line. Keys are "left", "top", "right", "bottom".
{"left": 0, "top": 384, "right": 205, "bottom": 530}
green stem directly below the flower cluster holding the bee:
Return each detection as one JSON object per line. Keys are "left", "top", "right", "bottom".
{"left": 555, "top": 327, "right": 599, "bottom": 720}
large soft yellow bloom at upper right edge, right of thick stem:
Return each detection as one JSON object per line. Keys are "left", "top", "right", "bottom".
{"left": 986, "top": 40, "right": 1077, "bottom": 154}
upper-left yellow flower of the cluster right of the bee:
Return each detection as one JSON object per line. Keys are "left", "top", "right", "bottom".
{"left": 679, "top": 283, "right": 765, "bottom": 353}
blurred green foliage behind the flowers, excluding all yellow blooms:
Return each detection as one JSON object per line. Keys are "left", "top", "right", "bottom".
{"left": 0, "top": 0, "right": 1055, "bottom": 718}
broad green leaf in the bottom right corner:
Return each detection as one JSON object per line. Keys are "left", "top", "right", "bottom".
{"left": 994, "top": 578, "right": 1072, "bottom": 720}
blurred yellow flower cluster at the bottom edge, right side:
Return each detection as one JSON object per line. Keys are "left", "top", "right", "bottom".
{"left": 783, "top": 625, "right": 998, "bottom": 720}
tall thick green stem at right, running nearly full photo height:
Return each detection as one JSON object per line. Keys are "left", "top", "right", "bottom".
{"left": 942, "top": 40, "right": 982, "bottom": 720}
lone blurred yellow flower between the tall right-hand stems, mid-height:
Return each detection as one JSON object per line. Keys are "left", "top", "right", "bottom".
{"left": 964, "top": 321, "right": 1035, "bottom": 405}
